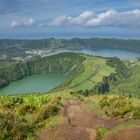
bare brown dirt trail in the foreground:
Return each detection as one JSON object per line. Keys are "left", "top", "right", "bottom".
{"left": 38, "top": 99, "right": 140, "bottom": 140}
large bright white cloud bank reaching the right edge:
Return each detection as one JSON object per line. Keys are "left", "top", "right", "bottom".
{"left": 51, "top": 9, "right": 140, "bottom": 27}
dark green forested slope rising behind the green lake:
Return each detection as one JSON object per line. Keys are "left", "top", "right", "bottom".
{"left": 0, "top": 53, "right": 84, "bottom": 88}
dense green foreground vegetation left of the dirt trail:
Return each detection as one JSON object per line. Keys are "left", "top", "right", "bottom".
{"left": 0, "top": 95, "right": 62, "bottom": 140}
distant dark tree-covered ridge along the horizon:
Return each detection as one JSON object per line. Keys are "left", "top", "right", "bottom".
{"left": 0, "top": 38, "right": 140, "bottom": 52}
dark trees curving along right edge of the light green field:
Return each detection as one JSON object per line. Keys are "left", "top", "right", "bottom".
{"left": 90, "top": 57, "right": 130, "bottom": 94}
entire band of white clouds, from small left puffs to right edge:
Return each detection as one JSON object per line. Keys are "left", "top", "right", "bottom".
{"left": 11, "top": 9, "right": 140, "bottom": 28}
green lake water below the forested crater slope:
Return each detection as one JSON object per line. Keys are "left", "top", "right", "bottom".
{"left": 0, "top": 73, "right": 67, "bottom": 95}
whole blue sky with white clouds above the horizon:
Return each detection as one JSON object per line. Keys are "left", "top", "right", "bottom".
{"left": 0, "top": 0, "right": 140, "bottom": 39}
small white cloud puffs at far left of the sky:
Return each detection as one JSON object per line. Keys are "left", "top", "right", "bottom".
{"left": 11, "top": 18, "right": 35, "bottom": 28}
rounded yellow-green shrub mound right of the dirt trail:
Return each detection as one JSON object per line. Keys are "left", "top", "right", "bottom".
{"left": 99, "top": 96, "right": 140, "bottom": 119}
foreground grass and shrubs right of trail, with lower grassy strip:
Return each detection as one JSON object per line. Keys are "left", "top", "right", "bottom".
{"left": 85, "top": 95, "right": 140, "bottom": 140}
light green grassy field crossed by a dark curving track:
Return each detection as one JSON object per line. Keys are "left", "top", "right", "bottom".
{"left": 66, "top": 56, "right": 115, "bottom": 91}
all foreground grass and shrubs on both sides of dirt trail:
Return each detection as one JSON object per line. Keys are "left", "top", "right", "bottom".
{"left": 0, "top": 92, "right": 140, "bottom": 140}
